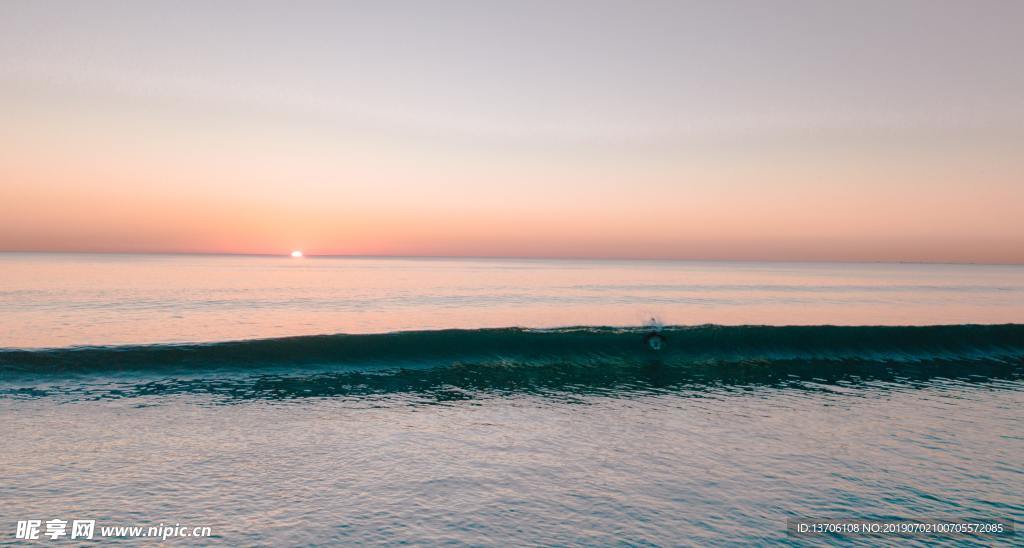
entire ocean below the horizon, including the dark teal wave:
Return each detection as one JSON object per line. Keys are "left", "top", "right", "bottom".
{"left": 0, "top": 253, "right": 1024, "bottom": 546}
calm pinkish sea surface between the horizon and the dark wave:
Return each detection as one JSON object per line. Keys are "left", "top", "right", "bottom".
{"left": 0, "top": 253, "right": 1024, "bottom": 347}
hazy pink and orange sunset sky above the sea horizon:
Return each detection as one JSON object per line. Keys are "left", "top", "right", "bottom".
{"left": 0, "top": 0, "right": 1024, "bottom": 263}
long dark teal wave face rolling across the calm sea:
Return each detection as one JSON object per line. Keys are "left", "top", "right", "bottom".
{"left": 0, "top": 324, "right": 1024, "bottom": 374}
